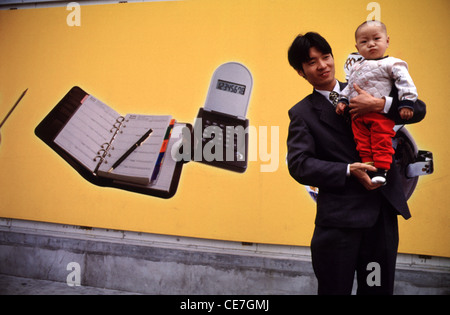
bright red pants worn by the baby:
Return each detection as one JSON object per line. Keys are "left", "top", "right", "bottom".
{"left": 352, "top": 113, "right": 395, "bottom": 170}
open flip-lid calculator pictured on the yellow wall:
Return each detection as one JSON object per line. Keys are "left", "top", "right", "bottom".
{"left": 194, "top": 62, "right": 253, "bottom": 173}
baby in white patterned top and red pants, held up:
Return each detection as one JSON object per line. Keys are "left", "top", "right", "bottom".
{"left": 336, "top": 21, "right": 417, "bottom": 185}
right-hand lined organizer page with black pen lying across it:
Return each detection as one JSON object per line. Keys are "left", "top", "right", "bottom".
{"left": 98, "top": 114, "right": 172, "bottom": 185}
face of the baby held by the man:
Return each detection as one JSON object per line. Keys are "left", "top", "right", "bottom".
{"left": 356, "top": 22, "right": 389, "bottom": 59}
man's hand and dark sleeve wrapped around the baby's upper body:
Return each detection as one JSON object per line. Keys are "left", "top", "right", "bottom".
{"left": 349, "top": 84, "right": 426, "bottom": 125}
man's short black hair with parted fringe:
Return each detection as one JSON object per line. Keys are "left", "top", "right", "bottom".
{"left": 288, "top": 32, "right": 333, "bottom": 71}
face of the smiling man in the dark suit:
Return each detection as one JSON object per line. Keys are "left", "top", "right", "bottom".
{"left": 298, "top": 47, "right": 336, "bottom": 91}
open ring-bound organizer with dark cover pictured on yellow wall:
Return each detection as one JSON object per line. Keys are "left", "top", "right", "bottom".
{"left": 35, "top": 86, "right": 192, "bottom": 198}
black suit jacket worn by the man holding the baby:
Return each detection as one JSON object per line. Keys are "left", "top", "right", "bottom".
{"left": 287, "top": 83, "right": 425, "bottom": 228}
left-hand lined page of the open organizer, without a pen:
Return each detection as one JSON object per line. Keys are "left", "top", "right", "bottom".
{"left": 55, "top": 95, "right": 120, "bottom": 172}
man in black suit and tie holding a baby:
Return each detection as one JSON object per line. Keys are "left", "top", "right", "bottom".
{"left": 287, "top": 32, "right": 425, "bottom": 294}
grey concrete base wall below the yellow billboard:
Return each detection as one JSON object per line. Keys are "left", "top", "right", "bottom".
{"left": 0, "top": 219, "right": 450, "bottom": 295}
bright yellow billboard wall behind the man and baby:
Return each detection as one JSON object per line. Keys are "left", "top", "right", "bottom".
{"left": 0, "top": 0, "right": 450, "bottom": 257}
